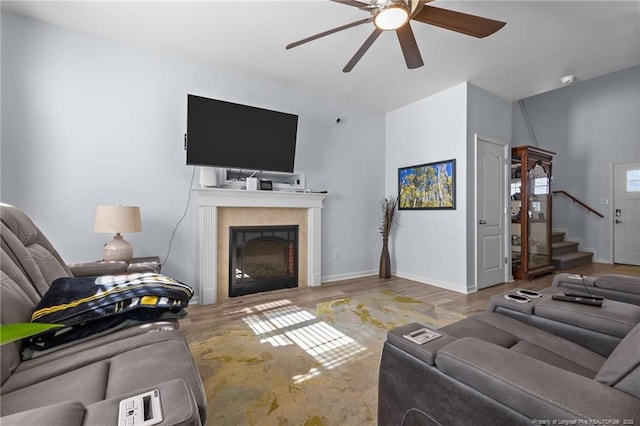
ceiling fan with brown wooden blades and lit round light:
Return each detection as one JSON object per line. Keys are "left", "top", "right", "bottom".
{"left": 286, "top": 0, "right": 506, "bottom": 72}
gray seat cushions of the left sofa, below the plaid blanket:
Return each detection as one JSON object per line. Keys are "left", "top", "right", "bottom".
{"left": 1, "top": 338, "right": 206, "bottom": 419}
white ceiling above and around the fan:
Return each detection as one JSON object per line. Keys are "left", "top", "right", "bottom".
{"left": 2, "top": 0, "right": 640, "bottom": 111}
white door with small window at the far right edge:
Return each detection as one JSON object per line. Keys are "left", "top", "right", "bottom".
{"left": 613, "top": 162, "right": 640, "bottom": 266}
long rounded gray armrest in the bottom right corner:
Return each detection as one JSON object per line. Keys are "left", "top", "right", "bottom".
{"left": 436, "top": 337, "right": 640, "bottom": 424}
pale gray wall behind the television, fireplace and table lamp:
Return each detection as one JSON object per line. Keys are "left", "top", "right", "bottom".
{"left": 1, "top": 13, "right": 384, "bottom": 300}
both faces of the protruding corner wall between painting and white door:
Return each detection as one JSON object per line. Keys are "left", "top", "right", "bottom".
{"left": 385, "top": 83, "right": 511, "bottom": 293}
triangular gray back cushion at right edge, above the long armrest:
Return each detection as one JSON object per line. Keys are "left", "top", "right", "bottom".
{"left": 595, "top": 324, "right": 640, "bottom": 398}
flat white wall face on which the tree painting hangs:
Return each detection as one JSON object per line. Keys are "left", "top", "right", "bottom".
{"left": 385, "top": 83, "right": 467, "bottom": 293}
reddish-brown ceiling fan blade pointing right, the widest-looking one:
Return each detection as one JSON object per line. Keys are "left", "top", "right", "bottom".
{"left": 412, "top": 5, "right": 506, "bottom": 38}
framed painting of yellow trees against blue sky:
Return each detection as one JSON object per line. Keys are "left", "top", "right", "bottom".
{"left": 398, "top": 159, "right": 456, "bottom": 210}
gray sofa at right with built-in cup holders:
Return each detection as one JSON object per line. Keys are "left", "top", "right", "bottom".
{"left": 378, "top": 280, "right": 640, "bottom": 426}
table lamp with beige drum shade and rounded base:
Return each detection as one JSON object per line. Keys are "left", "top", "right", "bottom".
{"left": 93, "top": 205, "right": 142, "bottom": 262}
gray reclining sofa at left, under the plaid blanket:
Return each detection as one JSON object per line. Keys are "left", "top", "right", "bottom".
{"left": 0, "top": 204, "right": 207, "bottom": 426}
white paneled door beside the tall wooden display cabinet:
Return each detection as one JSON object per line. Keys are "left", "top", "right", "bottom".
{"left": 476, "top": 136, "right": 507, "bottom": 289}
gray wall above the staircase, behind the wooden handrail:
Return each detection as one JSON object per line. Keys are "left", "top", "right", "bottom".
{"left": 513, "top": 66, "right": 640, "bottom": 263}
